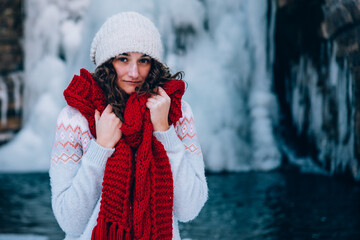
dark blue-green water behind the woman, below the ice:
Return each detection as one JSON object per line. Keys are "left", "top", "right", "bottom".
{"left": 0, "top": 172, "right": 360, "bottom": 240}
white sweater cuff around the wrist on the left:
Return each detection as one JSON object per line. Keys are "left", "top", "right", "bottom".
{"left": 84, "top": 139, "right": 115, "bottom": 168}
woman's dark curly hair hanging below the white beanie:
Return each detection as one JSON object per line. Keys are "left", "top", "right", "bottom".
{"left": 92, "top": 58, "right": 184, "bottom": 122}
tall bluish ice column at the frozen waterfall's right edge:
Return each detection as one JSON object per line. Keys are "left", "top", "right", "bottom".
{"left": 248, "top": 0, "right": 281, "bottom": 170}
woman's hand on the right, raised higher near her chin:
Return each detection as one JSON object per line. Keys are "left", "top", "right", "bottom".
{"left": 146, "top": 87, "right": 171, "bottom": 131}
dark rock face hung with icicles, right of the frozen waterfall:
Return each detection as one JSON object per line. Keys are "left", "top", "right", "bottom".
{"left": 274, "top": 0, "right": 360, "bottom": 180}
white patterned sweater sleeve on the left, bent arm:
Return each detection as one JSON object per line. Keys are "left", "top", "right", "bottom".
{"left": 49, "top": 106, "right": 114, "bottom": 237}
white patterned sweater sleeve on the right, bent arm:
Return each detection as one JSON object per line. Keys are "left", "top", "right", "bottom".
{"left": 154, "top": 101, "right": 208, "bottom": 222}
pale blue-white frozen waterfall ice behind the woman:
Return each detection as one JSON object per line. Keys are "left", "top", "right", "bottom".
{"left": 0, "top": 0, "right": 281, "bottom": 171}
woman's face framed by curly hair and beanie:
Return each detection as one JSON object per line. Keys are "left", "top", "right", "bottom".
{"left": 112, "top": 52, "right": 151, "bottom": 94}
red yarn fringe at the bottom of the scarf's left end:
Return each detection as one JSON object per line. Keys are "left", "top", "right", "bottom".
{"left": 91, "top": 218, "right": 131, "bottom": 240}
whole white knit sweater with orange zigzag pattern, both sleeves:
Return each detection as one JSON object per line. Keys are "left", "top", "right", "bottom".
{"left": 50, "top": 101, "right": 208, "bottom": 240}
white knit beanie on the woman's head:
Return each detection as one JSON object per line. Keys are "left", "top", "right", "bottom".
{"left": 90, "top": 12, "right": 163, "bottom": 67}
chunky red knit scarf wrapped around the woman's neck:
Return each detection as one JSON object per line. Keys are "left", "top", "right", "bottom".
{"left": 64, "top": 69, "right": 184, "bottom": 240}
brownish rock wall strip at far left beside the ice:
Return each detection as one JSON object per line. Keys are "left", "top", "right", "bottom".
{"left": 0, "top": 0, "right": 24, "bottom": 144}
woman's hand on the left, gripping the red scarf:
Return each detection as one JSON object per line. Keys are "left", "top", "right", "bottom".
{"left": 95, "top": 104, "right": 122, "bottom": 148}
